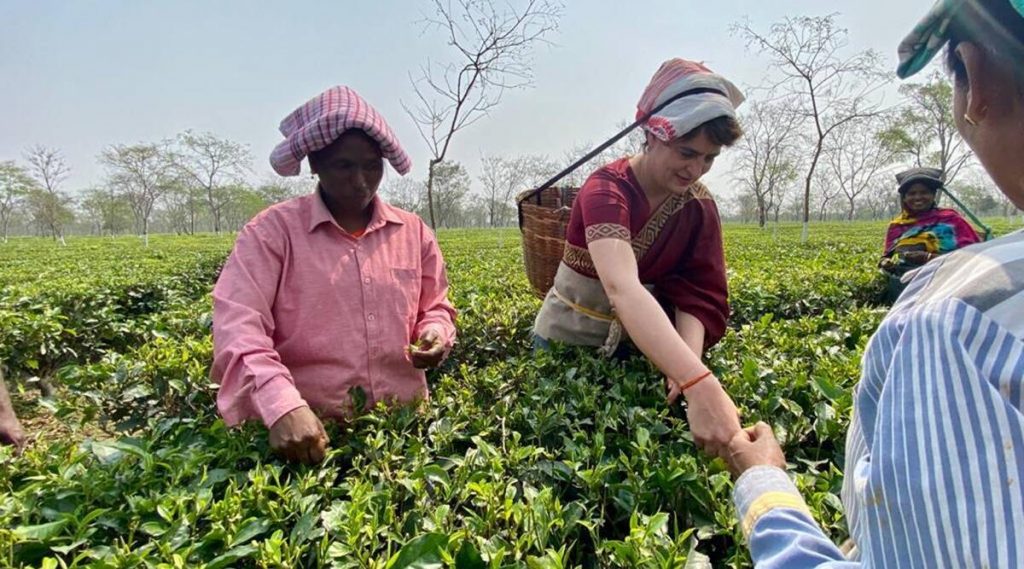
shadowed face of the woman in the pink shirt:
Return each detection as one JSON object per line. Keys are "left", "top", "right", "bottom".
{"left": 309, "top": 130, "right": 384, "bottom": 212}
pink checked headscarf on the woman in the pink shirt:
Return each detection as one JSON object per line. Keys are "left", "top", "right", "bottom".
{"left": 270, "top": 87, "right": 413, "bottom": 176}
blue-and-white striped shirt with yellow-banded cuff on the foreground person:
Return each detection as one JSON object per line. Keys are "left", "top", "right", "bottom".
{"left": 734, "top": 232, "right": 1024, "bottom": 568}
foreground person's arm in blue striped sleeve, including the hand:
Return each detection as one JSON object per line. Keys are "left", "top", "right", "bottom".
{"left": 727, "top": 300, "right": 1024, "bottom": 568}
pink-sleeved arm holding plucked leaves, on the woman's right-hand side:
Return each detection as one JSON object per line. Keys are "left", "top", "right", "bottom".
{"left": 411, "top": 225, "right": 456, "bottom": 367}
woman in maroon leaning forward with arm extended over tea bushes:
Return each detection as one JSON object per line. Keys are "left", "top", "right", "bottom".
{"left": 534, "top": 59, "right": 743, "bottom": 454}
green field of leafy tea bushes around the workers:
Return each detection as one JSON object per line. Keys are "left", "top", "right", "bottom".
{"left": 0, "top": 223, "right": 1006, "bottom": 569}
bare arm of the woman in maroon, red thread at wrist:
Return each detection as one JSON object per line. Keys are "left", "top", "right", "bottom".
{"left": 589, "top": 238, "right": 739, "bottom": 454}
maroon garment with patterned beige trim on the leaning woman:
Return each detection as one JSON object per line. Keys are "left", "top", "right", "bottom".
{"left": 563, "top": 159, "right": 729, "bottom": 347}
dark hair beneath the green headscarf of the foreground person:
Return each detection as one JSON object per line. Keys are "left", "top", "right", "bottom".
{"left": 946, "top": 0, "right": 1024, "bottom": 86}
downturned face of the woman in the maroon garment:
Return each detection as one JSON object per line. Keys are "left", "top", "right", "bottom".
{"left": 646, "top": 131, "right": 722, "bottom": 193}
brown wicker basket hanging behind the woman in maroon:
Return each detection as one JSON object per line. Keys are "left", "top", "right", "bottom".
{"left": 516, "top": 187, "right": 579, "bottom": 299}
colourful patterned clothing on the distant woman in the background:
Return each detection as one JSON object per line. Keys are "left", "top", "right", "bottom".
{"left": 885, "top": 208, "right": 981, "bottom": 257}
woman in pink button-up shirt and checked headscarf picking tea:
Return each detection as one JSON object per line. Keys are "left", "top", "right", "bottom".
{"left": 212, "top": 87, "right": 456, "bottom": 464}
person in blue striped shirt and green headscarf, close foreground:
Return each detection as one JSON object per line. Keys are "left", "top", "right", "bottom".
{"left": 725, "top": 0, "right": 1024, "bottom": 568}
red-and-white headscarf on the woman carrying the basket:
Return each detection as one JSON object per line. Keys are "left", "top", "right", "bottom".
{"left": 636, "top": 58, "right": 744, "bottom": 142}
